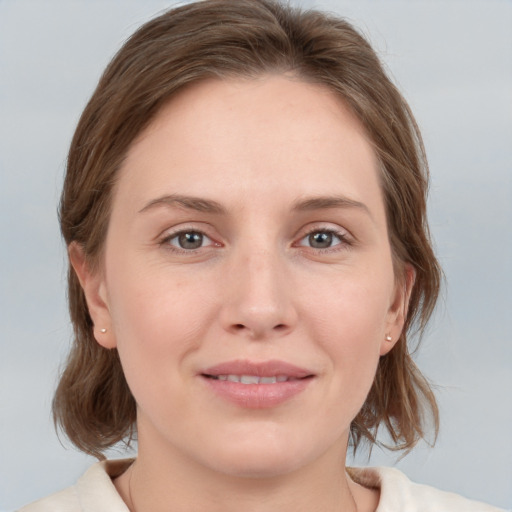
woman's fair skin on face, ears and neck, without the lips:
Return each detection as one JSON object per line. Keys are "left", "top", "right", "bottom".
{"left": 70, "top": 75, "right": 413, "bottom": 512}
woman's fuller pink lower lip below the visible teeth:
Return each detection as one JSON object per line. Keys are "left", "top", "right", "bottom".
{"left": 202, "top": 376, "right": 313, "bottom": 409}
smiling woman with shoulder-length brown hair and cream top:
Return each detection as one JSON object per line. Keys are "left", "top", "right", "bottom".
{"left": 18, "top": 0, "right": 506, "bottom": 512}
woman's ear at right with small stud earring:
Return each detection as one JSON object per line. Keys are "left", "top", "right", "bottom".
{"left": 380, "top": 263, "right": 416, "bottom": 356}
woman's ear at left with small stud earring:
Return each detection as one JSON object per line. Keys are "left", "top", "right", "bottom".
{"left": 68, "top": 242, "right": 116, "bottom": 349}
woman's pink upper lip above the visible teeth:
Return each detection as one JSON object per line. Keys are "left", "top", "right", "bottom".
{"left": 200, "top": 359, "right": 313, "bottom": 379}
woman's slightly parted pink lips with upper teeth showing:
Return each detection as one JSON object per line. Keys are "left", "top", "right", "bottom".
{"left": 199, "top": 360, "right": 315, "bottom": 409}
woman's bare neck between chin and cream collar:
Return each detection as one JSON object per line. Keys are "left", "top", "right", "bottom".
{"left": 115, "top": 440, "right": 366, "bottom": 512}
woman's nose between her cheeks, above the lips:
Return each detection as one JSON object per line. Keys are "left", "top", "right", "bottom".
{"left": 220, "top": 250, "right": 298, "bottom": 340}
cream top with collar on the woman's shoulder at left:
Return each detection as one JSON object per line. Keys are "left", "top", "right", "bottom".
{"left": 18, "top": 459, "right": 132, "bottom": 512}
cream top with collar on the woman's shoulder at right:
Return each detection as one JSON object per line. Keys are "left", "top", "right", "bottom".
{"left": 348, "top": 468, "right": 503, "bottom": 512}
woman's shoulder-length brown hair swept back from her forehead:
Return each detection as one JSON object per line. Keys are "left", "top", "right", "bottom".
{"left": 53, "top": 0, "right": 441, "bottom": 458}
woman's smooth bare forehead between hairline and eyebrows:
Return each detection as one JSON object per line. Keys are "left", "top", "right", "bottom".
{"left": 118, "top": 75, "right": 382, "bottom": 222}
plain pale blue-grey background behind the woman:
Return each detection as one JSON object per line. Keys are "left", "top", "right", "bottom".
{"left": 0, "top": 0, "right": 512, "bottom": 510}
